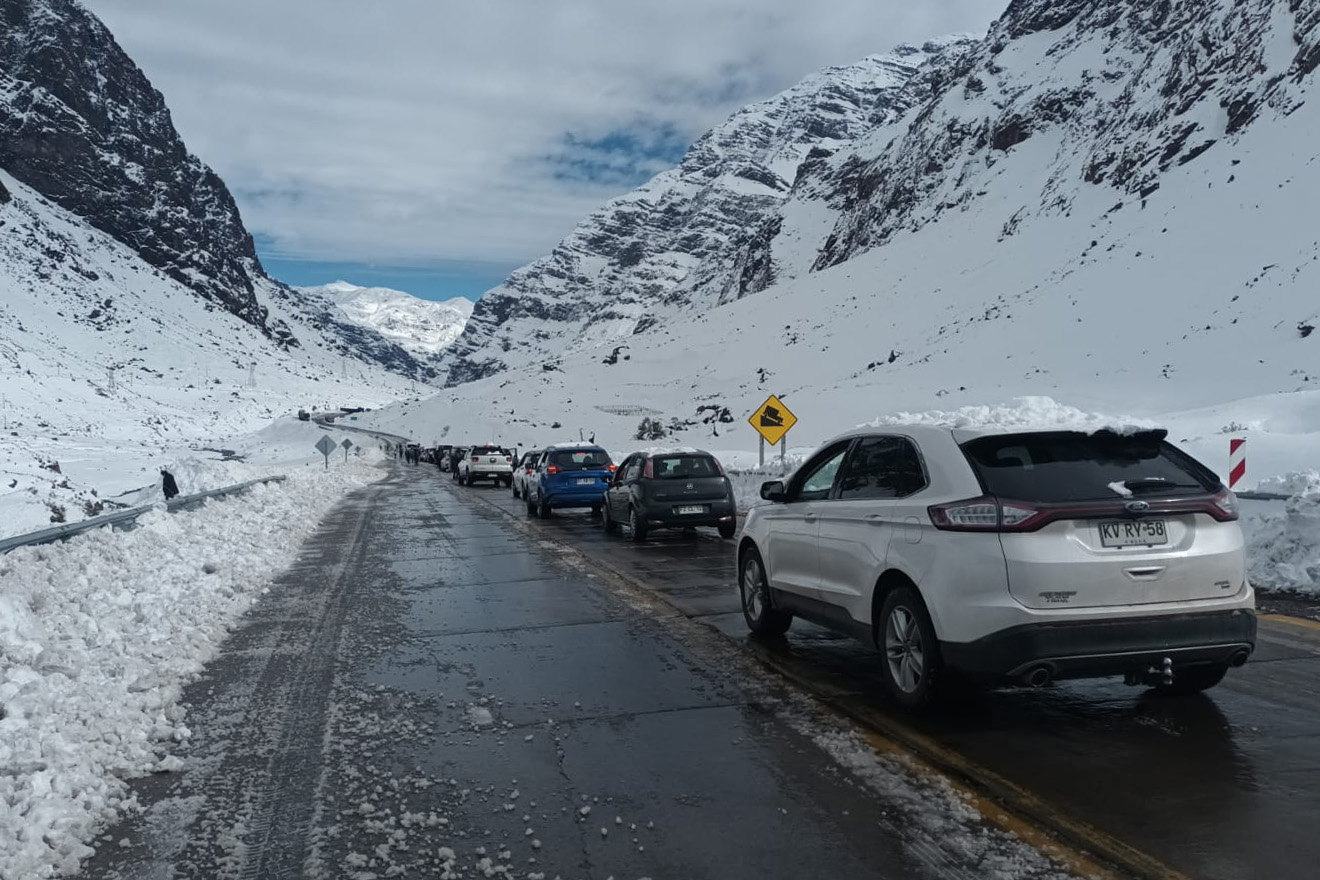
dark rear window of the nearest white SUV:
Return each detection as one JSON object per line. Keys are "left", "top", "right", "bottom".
{"left": 962, "top": 431, "right": 1220, "bottom": 503}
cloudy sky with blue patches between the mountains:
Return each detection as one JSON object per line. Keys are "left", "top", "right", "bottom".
{"left": 83, "top": 0, "right": 1006, "bottom": 299}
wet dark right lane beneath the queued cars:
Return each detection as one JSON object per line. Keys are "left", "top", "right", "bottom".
{"left": 467, "top": 477, "right": 1320, "bottom": 880}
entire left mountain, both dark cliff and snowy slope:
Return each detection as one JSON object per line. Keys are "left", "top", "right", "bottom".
{"left": 0, "top": 0, "right": 464, "bottom": 534}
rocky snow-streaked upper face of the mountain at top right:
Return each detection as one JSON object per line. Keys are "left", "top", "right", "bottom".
{"left": 797, "top": 0, "right": 1320, "bottom": 269}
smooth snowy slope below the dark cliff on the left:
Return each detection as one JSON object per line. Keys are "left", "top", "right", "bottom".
{"left": 0, "top": 172, "right": 413, "bottom": 536}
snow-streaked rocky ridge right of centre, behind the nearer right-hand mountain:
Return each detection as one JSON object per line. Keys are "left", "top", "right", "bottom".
{"left": 445, "top": 41, "right": 961, "bottom": 384}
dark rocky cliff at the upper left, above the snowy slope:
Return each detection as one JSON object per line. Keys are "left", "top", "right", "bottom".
{"left": 0, "top": 0, "right": 287, "bottom": 344}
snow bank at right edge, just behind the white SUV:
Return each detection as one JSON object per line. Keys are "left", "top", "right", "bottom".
{"left": 1246, "top": 471, "right": 1320, "bottom": 595}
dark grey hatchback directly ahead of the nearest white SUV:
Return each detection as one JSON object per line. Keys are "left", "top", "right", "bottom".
{"left": 602, "top": 450, "right": 738, "bottom": 541}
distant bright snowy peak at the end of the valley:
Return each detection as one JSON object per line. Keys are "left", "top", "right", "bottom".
{"left": 300, "top": 281, "right": 473, "bottom": 358}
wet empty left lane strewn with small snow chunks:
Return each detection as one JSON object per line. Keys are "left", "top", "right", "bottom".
{"left": 83, "top": 463, "right": 1082, "bottom": 880}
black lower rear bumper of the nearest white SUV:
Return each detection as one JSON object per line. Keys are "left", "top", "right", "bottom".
{"left": 940, "top": 608, "right": 1255, "bottom": 679}
